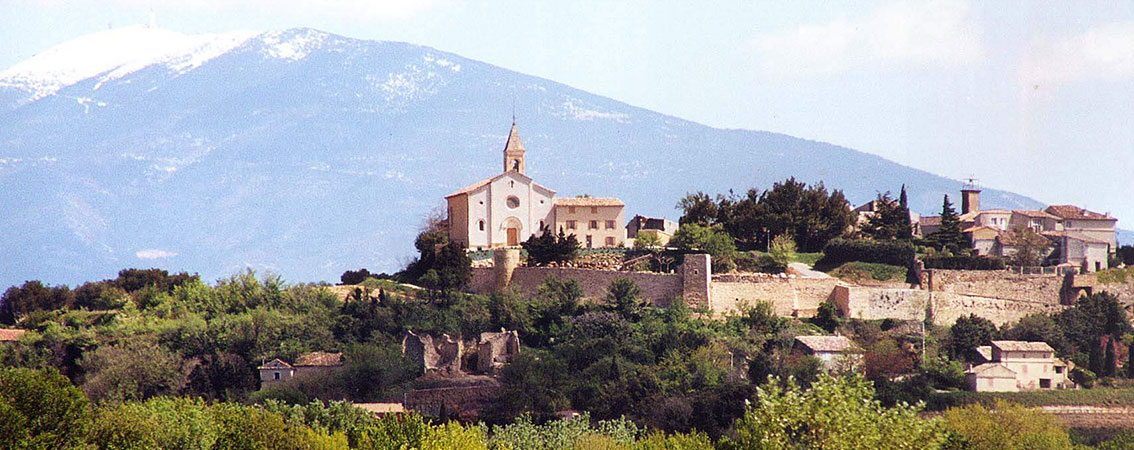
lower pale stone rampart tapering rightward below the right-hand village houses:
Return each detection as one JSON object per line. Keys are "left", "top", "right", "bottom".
{"left": 832, "top": 286, "right": 1065, "bottom": 325}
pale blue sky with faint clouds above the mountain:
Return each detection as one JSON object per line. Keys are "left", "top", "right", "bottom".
{"left": 0, "top": 0, "right": 1134, "bottom": 222}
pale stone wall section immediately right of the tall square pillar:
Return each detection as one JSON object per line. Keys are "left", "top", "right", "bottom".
{"left": 711, "top": 274, "right": 845, "bottom": 317}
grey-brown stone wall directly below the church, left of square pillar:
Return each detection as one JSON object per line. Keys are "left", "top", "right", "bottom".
{"left": 469, "top": 268, "right": 682, "bottom": 306}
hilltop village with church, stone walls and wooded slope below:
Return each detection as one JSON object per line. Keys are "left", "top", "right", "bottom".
{"left": 0, "top": 124, "right": 1134, "bottom": 449}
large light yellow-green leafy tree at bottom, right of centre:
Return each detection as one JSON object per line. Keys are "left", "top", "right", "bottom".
{"left": 719, "top": 374, "right": 946, "bottom": 450}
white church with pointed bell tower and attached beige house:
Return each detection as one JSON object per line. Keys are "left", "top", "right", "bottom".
{"left": 445, "top": 121, "right": 626, "bottom": 249}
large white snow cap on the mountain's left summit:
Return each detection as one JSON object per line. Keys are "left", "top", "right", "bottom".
{"left": 0, "top": 26, "right": 255, "bottom": 102}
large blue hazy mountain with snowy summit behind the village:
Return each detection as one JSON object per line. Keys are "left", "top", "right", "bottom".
{"left": 0, "top": 27, "right": 1097, "bottom": 286}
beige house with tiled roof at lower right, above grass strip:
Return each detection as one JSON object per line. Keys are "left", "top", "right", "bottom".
{"left": 965, "top": 341, "right": 1075, "bottom": 392}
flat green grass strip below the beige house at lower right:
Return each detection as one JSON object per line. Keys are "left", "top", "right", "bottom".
{"left": 926, "top": 388, "right": 1134, "bottom": 410}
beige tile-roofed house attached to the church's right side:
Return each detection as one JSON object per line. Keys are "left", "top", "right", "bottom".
{"left": 555, "top": 197, "right": 626, "bottom": 248}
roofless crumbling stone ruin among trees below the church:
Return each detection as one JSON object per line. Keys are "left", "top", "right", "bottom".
{"left": 401, "top": 330, "right": 519, "bottom": 377}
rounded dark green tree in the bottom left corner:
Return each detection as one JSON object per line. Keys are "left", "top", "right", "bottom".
{"left": 0, "top": 368, "right": 91, "bottom": 450}
